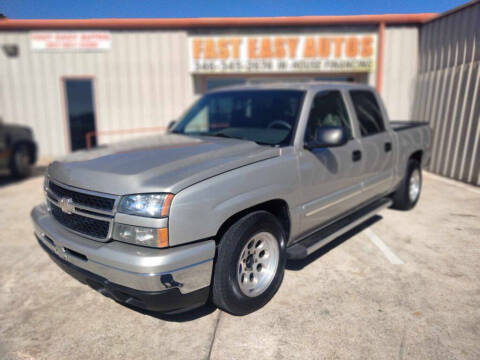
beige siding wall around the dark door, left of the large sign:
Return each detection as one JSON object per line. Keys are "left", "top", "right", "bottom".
{"left": 0, "top": 31, "right": 194, "bottom": 156}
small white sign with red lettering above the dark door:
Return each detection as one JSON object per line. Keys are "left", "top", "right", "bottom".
{"left": 30, "top": 31, "right": 112, "bottom": 51}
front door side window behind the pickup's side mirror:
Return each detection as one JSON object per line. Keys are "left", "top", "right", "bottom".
{"left": 305, "top": 90, "right": 352, "bottom": 141}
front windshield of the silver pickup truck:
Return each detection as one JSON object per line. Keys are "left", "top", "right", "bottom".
{"left": 172, "top": 90, "right": 305, "bottom": 145}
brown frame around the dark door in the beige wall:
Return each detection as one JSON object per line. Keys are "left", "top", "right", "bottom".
{"left": 59, "top": 75, "right": 98, "bottom": 154}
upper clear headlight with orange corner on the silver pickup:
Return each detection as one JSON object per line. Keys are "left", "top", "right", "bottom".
{"left": 118, "top": 194, "right": 173, "bottom": 218}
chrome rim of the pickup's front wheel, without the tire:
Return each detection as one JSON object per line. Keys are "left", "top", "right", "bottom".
{"left": 237, "top": 232, "right": 280, "bottom": 297}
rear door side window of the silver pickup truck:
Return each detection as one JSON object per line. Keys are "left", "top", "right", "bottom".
{"left": 350, "top": 90, "right": 385, "bottom": 136}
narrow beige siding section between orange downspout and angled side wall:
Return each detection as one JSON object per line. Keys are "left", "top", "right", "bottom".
{"left": 381, "top": 26, "right": 418, "bottom": 120}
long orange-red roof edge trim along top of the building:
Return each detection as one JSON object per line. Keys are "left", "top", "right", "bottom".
{"left": 0, "top": 13, "right": 438, "bottom": 30}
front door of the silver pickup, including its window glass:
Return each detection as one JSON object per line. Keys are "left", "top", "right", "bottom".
{"left": 299, "top": 90, "right": 363, "bottom": 235}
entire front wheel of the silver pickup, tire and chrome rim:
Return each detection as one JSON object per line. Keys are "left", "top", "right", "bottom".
{"left": 212, "top": 211, "right": 287, "bottom": 315}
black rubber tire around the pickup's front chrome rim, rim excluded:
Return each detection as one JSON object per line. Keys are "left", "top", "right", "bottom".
{"left": 213, "top": 211, "right": 286, "bottom": 315}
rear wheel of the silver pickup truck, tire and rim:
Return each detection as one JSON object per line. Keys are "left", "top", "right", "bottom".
{"left": 392, "top": 159, "right": 422, "bottom": 210}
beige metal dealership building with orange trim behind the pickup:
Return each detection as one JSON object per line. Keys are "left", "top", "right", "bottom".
{"left": 0, "top": 1, "right": 480, "bottom": 185}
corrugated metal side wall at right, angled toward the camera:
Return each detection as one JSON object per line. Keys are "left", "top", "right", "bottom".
{"left": 412, "top": 2, "right": 480, "bottom": 185}
